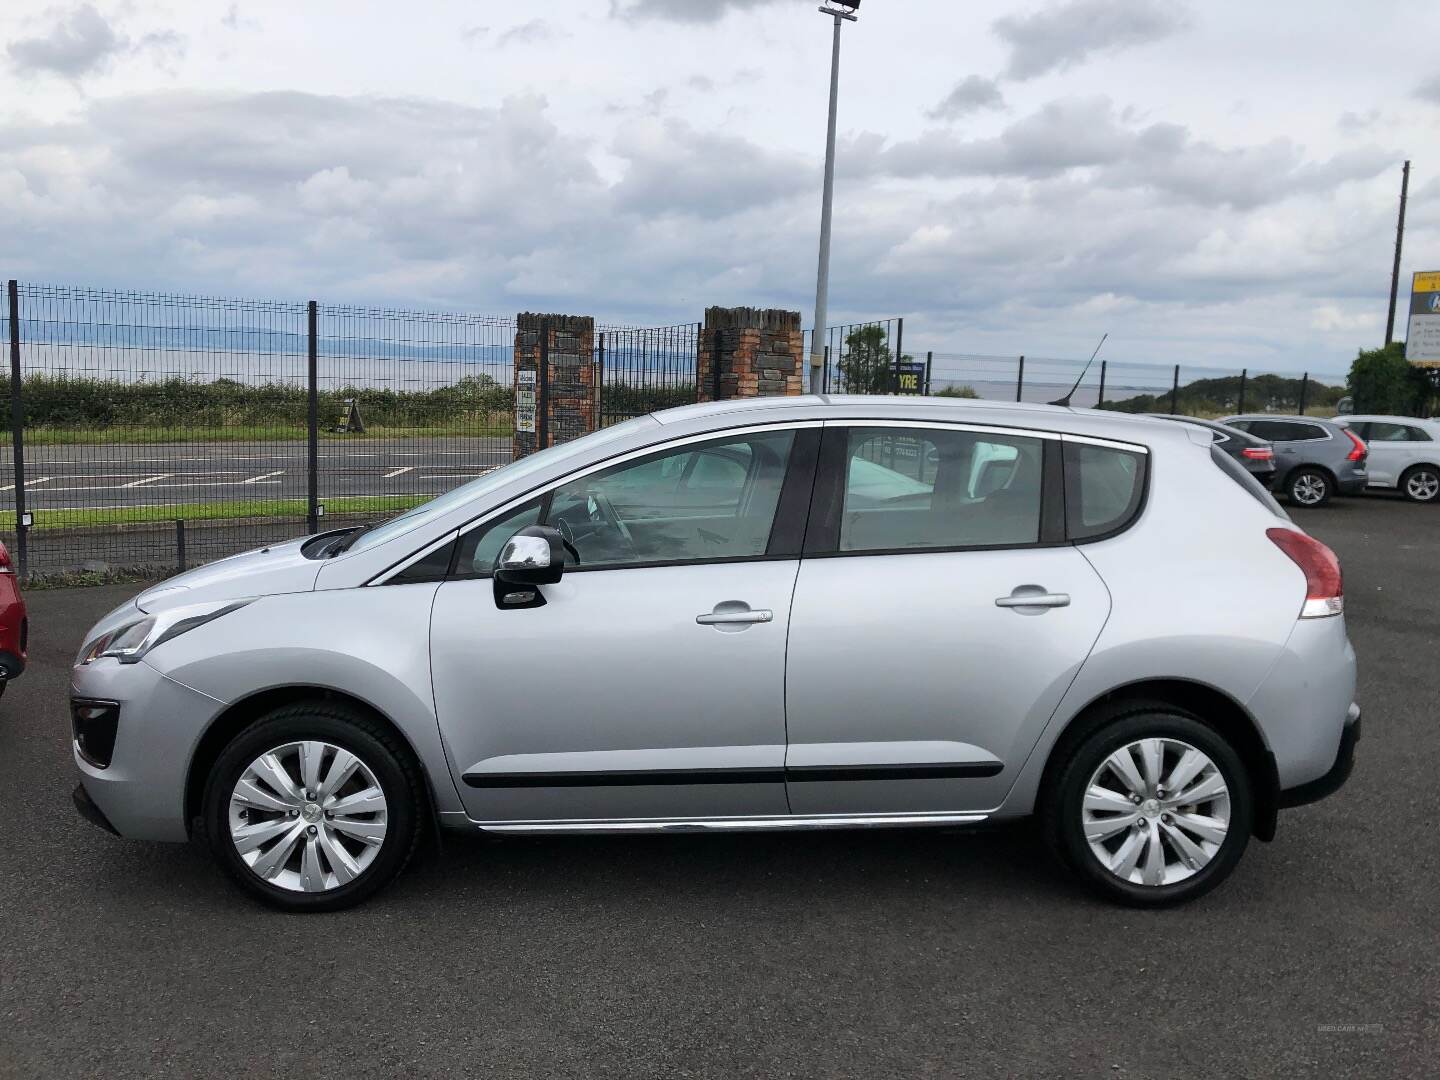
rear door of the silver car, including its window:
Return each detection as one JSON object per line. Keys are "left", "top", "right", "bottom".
{"left": 786, "top": 425, "right": 1111, "bottom": 814}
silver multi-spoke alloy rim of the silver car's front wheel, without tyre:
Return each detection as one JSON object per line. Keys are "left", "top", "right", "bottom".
{"left": 229, "top": 740, "right": 387, "bottom": 893}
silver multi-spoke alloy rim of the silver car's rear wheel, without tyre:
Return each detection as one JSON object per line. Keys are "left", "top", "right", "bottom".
{"left": 1080, "top": 737, "right": 1230, "bottom": 886}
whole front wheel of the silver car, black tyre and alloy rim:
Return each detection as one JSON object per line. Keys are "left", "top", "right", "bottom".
{"left": 203, "top": 701, "right": 425, "bottom": 912}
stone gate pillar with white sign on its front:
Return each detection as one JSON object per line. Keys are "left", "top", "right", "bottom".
{"left": 513, "top": 311, "right": 599, "bottom": 458}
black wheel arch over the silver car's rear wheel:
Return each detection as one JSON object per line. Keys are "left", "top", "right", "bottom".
{"left": 1040, "top": 678, "right": 1280, "bottom": 840}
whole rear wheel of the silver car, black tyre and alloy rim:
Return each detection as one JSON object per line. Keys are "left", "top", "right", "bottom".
{"left": 1041, "top": 704, "right": 1254, "bottom": 907}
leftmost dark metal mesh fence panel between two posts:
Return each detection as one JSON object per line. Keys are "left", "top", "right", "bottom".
{"left": 0, "top": 285, "right": 305, "bottom": 573}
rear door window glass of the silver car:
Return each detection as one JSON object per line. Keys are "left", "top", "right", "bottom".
{"left": 838, "top": 428, "right": 1044, "bottom": 552}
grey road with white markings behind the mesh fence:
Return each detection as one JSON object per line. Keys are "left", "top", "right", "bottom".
{"left": 0, "top": 436, "right": 510, "bottom": 511}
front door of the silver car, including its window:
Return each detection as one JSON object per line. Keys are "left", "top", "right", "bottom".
{"left": 431, "top": 428, "right": 818, "bottom": 822}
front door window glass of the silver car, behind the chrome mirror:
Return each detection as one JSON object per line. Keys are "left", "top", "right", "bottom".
{"left": 458, "top": 431, "right": 795, "bottom": 576}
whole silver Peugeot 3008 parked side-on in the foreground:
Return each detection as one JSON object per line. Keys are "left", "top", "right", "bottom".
{"left": 72, "top": 397, "right": 1359, "bottom": 912}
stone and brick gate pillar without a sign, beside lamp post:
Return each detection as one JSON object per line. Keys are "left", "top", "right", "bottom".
{"left": 696, "top": 307, "right": 805, "bottom": 402}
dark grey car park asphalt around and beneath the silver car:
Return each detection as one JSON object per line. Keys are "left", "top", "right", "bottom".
{"left": 0, "top": 498, "right": 1440, "bottom": 1077}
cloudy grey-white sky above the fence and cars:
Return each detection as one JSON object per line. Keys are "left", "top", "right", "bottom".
{"left": 0, "top": 0, "right": 1440, "bottom": 372}
